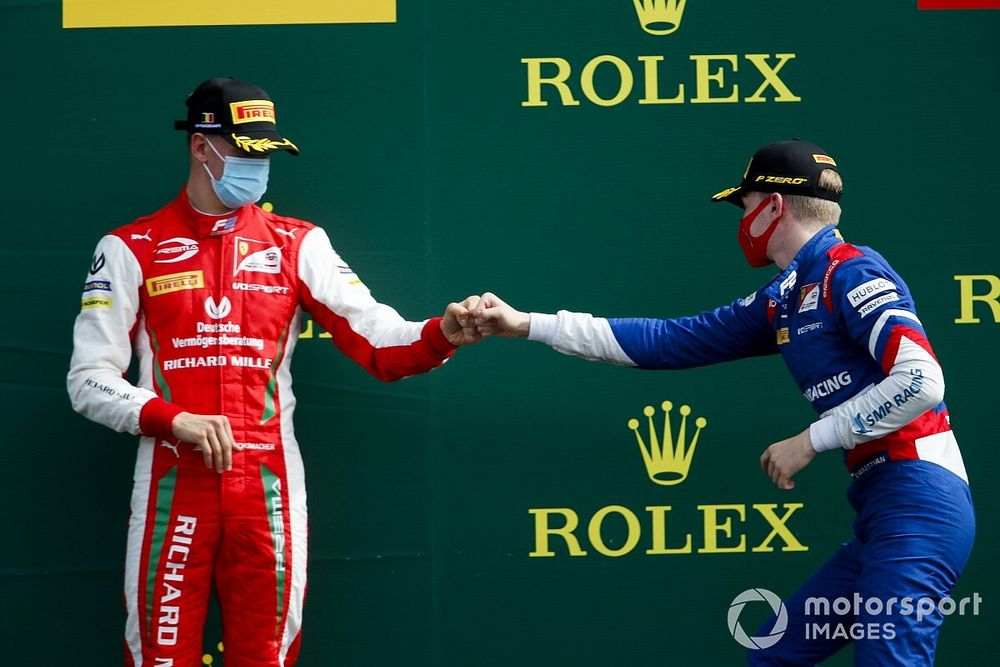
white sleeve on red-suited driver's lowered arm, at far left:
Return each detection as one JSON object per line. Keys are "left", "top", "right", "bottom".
{"left": 66, "top": 235, "right": 156, "bottom": 435}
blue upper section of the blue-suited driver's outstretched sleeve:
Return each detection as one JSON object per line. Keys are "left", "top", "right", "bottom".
{"left": 608, "top": 290, "right": 778, "bottom": 369}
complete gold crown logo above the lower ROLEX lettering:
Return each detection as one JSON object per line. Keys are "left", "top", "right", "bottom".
{"left": 628, "top": 401, "right": 708, "bottom": 486}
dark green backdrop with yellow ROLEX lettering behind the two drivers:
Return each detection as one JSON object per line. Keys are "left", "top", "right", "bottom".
{"left": 0, "top": 0, "right": 1000, "bottom": 667}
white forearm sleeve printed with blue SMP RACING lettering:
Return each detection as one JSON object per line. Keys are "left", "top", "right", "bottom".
{"left": 809, "top": 338, "right": 944, "bottom": 452}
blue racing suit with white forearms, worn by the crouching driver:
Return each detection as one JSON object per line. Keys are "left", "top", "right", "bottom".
{"left": 529, "top": 226, "right": 975, "bottom": 666}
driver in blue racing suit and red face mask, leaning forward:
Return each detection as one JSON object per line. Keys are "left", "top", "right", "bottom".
{"left": 475, "top": 140, "right": 975, "bottom": 667}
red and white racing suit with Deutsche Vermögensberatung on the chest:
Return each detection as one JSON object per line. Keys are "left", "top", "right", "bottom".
{"left": 67, "top": 192, "right": 454, "bottom": 667}
